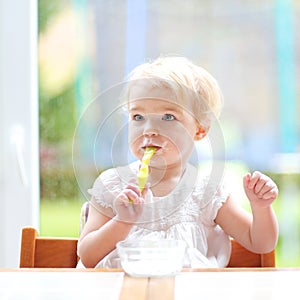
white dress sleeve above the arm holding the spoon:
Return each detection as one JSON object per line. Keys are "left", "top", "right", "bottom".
{"left": 88, "top": 169, "right": 122, "bottom": 210}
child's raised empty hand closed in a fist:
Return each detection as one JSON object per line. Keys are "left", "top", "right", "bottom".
{"left": 243, "top": 171, "right": 278, "bottom": 207}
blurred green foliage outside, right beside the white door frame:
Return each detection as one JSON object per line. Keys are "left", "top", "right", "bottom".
{"left": 38, "top": 0, "right": 79, "bottom": 200}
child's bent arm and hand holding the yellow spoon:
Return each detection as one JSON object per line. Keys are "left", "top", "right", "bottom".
{"left": 78, "top": 180, "right": 146, "bottom": 268}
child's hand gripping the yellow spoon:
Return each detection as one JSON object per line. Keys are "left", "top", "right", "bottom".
{"left": 114, "top": 182, "right": 146, "bottom": 223}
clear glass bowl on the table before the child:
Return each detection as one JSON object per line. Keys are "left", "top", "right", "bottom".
{"left": 117, "top": 239, "right": 186, "bottom": 277}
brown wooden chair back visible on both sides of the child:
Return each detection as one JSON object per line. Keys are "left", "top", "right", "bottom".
{"left": 20, "top": 227, "right": 275, "bottom": 268}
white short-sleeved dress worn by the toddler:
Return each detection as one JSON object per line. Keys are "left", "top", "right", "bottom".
{"left": 82, "top": 162, "right": 231, "bottom": 268}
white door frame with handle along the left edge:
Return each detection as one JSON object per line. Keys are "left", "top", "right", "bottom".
{"left": 0, "top": 0, "right": 39, "bottom": 267}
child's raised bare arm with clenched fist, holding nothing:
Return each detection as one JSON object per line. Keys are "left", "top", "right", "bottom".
{"left": 216, "top": 172, "right": 278, "bottom": 253}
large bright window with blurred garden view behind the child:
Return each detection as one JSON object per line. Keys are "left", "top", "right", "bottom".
{"left": 39, "top": 0, "right": 300, "bottom": 265}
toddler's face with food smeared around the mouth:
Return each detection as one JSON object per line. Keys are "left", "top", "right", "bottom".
{"left": 128, "top": 84, "right": 205, "bottom": 166}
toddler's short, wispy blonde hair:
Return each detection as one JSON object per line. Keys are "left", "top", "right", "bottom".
{"left": 124, "top": 56, "right": 223, "bottom": 128}
